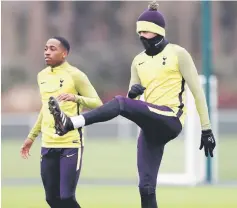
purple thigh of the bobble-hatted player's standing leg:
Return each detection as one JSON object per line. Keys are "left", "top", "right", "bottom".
{"left": 137, "top": 131, "right": 164, "bottom": 187}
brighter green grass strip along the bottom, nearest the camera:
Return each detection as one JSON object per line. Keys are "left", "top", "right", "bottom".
{"left": 2, "top": 186, "right": 237, "bottom": 208}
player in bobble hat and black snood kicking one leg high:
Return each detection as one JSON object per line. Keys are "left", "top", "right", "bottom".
{"left": 49, "top": 2, "right": 216, "bottom": 208}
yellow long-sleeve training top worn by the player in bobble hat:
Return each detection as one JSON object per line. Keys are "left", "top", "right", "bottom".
{"left": 129, "top": 44, "right": 211, "bottom": 130}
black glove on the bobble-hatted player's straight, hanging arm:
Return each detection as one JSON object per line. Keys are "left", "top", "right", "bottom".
{"left": 199, "top": 129, "right": 216, "bottom": 157}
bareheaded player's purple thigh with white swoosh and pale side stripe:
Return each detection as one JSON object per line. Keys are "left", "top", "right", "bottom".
{"left": 60, "top": 147, "right": 84, "bottom": 199}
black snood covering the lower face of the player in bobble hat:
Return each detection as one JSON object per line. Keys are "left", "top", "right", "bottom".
{"left": 140, "top": 35, "right": 168, "bottom": 56}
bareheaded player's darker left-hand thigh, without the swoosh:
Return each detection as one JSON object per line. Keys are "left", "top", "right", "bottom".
{"left": 40, "top": 147, "right": 60, "bottom": 198}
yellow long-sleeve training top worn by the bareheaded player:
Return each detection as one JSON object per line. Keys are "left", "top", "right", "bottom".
{"left": 28, "top": 62, "right": 102, "bottom": 148}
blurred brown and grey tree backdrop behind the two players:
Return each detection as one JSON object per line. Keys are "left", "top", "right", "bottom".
{"left": 2, "top": 1, "right": 237, "bottom": 112}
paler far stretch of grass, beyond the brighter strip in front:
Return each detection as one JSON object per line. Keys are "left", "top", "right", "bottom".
{"left": 2, "top": 137, "right": 237, "bottom": 181}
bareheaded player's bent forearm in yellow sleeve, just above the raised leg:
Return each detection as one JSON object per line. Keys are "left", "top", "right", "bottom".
{"left": 75, "top": 95, "right": 103, "bottom": 109}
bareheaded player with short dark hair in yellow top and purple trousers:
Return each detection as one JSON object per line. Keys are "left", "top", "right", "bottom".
{"left": 21, "top": 37, "right": 102, "bottom": 208}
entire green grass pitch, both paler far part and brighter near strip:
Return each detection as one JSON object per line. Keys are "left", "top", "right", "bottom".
{"left": 2, "top": 137, "right": 237, "bottom": 208}
